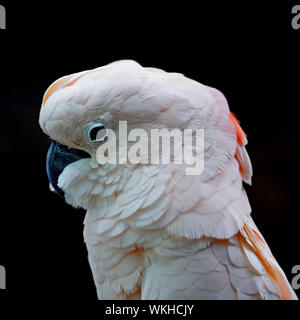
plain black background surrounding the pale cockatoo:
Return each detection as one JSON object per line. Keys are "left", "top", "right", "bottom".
{"left": 0, "top": 1, "right": 300, "bottom": 299}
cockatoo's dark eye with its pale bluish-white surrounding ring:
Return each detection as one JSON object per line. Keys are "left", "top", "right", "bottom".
{"left": 84, "top": 121, "right": 109, "bottom": 148}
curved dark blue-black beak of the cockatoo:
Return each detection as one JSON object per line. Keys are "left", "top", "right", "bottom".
{"left": 46, "top": 140, "right": 90, "bottom": 198}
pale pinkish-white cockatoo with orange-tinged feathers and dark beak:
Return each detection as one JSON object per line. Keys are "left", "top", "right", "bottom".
{"left": 39, "top": 60, "right": 297, "bottom": 300}
